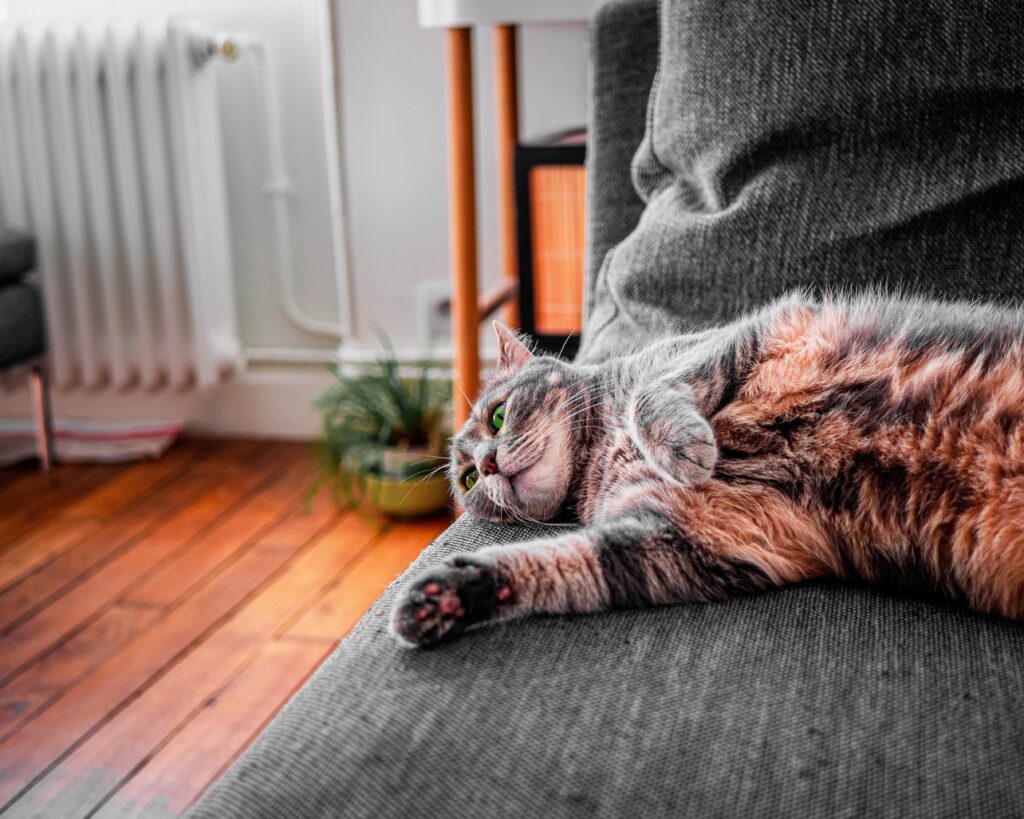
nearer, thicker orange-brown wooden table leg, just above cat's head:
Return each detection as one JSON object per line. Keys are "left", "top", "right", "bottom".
{"left": 444, "top": 29, "right": 480, "bottom": 430}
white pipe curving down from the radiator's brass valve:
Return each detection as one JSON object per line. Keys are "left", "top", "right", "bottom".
{"left": 205, "top": 34, "right": 344, "bottom": 339}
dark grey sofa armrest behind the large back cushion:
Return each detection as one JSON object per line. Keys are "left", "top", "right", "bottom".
{"left": 585, "top": 0, "right": 658, "bottom": 324}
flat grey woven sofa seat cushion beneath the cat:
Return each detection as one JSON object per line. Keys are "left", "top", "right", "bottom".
{"left": 193, "top": 518, "right": 1024, "bottom": 819}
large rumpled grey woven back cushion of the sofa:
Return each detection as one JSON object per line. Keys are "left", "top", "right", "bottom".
{"left": 582, "top": 0, "right": 1024, "bottom": 360}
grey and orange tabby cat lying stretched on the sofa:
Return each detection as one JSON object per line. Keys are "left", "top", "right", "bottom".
{"left": 392, "top": 294, "right": 1024, "bottom": 646}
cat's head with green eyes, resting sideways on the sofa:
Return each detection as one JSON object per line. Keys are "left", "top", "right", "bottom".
{"left": 449, "top": 321, "right": 588, "bottom": 520}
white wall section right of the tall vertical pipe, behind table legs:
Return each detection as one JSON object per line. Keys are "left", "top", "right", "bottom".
{"left": 336, "top": 0, "right": 586, "bottom": 346}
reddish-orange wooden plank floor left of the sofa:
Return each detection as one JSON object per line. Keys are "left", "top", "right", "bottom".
{"left": 0, "top": 440, "right": 447, "bottom": 819}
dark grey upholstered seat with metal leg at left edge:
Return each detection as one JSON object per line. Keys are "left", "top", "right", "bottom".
{"left": 0, "top": 227, "right": 53, "bottom": 471}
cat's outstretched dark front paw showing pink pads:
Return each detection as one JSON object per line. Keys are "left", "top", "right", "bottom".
{"left": 391, "top": 555, "right": 513, "bottom": 647}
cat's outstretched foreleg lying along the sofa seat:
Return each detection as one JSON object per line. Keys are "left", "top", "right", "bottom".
{"left": 392, "top": 483, "right": 827, "bottom": 646}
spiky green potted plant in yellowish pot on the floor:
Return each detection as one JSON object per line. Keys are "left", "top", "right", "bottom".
{"left": 314, "top": 336, "right": 451, "bottom": 517}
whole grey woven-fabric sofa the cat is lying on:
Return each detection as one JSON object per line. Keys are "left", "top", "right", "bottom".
{"left": 194, "top": 0, "right": 1024, "bottom": 819}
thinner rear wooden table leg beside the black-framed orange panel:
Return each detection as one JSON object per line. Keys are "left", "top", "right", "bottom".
{"left": 495, "top": 25, "right": 519, "bottom": 328}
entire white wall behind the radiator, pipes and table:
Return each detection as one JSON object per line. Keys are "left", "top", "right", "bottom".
{"left": 0, "top": 0, "right": 586, "bottom": 437}
